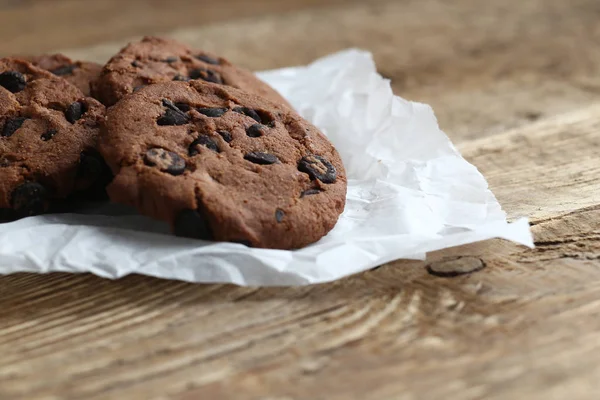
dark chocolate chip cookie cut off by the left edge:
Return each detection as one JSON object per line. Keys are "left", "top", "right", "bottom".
{"left": 0, "top": 58, "right": 105, "bottom": 219}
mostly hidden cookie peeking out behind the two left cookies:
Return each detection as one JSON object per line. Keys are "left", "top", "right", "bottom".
{"left": 24, "top": 54, "right": 102, "bottom": 96}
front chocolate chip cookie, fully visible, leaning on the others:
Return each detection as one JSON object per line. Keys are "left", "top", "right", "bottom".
{"left": 99, "top": 81, "right": 347, "bottom": 249}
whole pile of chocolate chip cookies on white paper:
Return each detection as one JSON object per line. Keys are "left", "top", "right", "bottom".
{"left": 0, "top": 37, "right": 346, "bottom": 249}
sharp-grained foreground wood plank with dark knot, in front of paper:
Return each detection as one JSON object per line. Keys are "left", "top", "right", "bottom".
{"left": 0, "top": 105, "right": 600, "bottom": 400}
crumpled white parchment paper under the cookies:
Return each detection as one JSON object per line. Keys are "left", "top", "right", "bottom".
{"left": 0, "top": 50, "right": 533, "bottom": 286}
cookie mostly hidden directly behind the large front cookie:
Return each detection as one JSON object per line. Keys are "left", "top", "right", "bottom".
{"left": 92, "top": 37, "right": 290, "bottom": 107}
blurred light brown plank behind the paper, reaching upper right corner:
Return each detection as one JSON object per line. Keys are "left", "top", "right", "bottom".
{"left": 61, "top": 0, "right": 600, "bottom": 142}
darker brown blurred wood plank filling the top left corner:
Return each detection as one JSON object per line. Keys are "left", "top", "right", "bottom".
{"left": 0, "top": 0, "right": 360, "bottom": 56}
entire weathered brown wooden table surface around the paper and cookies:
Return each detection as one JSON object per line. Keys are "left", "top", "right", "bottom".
{"left": 0, "top": 0, "right": 600, "bottom": 400}
